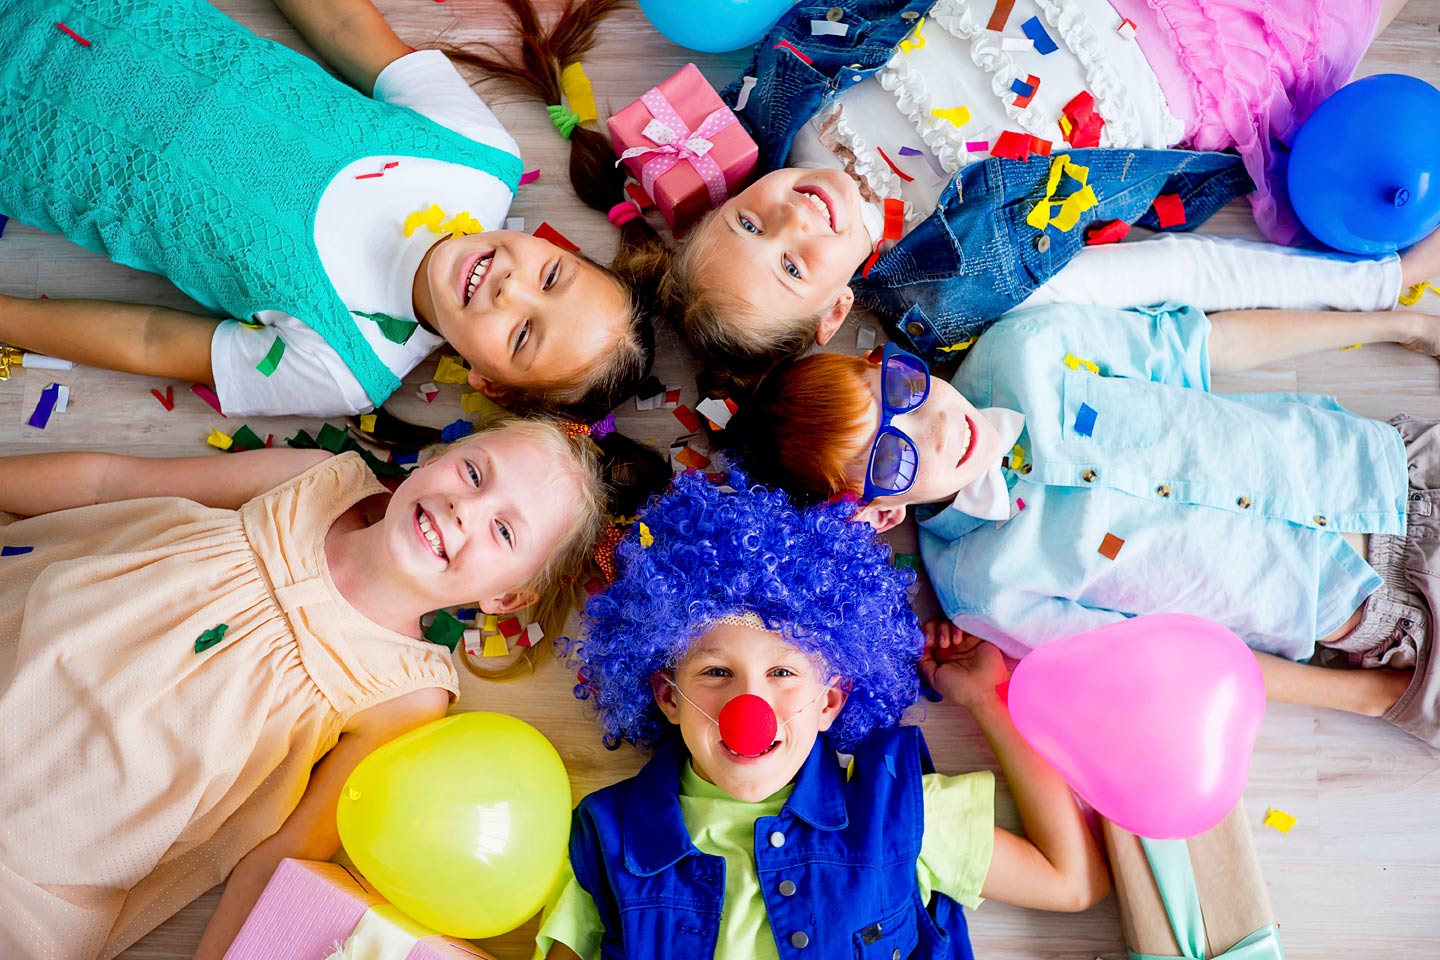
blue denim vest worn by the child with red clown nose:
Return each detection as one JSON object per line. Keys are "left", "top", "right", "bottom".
{"left": 570, "top": 727, "right": 973, "bottom": 960}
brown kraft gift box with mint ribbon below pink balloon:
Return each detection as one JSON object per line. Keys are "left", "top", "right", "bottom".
{"left": 1103, "top": 806, "right": 1283, "bottom": 960}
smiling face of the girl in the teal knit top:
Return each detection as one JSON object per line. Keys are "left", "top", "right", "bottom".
{"left": 413, "top": 230, "right": 629, "bottom": 396}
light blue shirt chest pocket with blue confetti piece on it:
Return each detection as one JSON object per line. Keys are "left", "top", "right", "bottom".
{"left": 1060, "top": 368, "right": 1169, "bottom": 450}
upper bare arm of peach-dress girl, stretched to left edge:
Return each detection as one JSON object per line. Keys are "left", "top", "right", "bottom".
{"left": 0, "top": 449, "right": 330, "bottom": 517}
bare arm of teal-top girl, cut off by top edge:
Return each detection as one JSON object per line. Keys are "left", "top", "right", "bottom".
{"left": 275, "top": 0, "right": 415, "bottom": 95}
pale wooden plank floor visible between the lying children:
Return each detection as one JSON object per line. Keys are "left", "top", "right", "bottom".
{"left": 0, "top": 0, "right": 1440, "bottom": 960}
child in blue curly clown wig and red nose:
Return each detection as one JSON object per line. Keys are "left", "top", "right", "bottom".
{"left": 537, "top": 474, "right": 1109, "bottom": 960}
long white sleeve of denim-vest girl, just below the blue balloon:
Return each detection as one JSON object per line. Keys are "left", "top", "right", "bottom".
{"left": 1021, "top": 233, "right": 1400, "bottom": 312}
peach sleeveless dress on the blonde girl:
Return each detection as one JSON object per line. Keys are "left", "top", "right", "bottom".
{"left": 0, "top": 453, "right": 459, "bottom": 960}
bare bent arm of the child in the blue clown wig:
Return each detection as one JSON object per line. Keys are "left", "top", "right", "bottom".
{"left": 920, "top": 620, "right": 1110, "bottom": 911}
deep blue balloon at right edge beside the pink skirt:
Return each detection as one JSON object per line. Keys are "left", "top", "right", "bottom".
{"left": 1287, "top": 73, "right": 1440, "bottom": 255}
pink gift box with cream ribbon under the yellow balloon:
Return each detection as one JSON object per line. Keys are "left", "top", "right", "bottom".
{"left": 225, "top": 859, "right": 492, "bottom": 960}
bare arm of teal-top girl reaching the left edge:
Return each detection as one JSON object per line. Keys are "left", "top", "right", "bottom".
{"left": 0, "top": 296, "right": 220, "bottom": 384}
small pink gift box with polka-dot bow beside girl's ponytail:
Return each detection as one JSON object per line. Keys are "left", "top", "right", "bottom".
{"left": 608, "top": 63, "right": 760, "bottom": 233}
